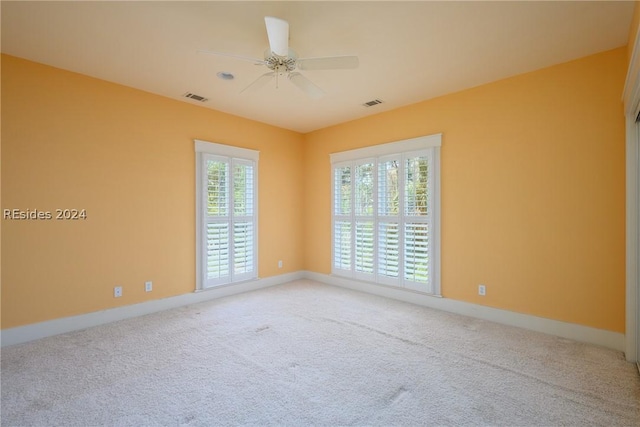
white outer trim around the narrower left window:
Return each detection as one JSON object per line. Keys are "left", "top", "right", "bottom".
{"left": 194, "top": 139, "right": 260, "bottom": 291}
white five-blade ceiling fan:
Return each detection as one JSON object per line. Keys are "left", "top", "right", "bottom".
{"left": 198, "top": 16, "right": 358, "bottom": 99}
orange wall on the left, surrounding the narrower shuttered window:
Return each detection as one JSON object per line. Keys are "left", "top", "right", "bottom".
{"left": 2, "top": 55, "right": 303, "bottom": 328}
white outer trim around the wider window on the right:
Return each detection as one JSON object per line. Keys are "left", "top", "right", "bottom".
{"left": 330, "top": 133, "right": 442, "bottom": 296}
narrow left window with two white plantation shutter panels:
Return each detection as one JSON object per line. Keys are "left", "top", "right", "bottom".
{"left": 196, "top": 141, "right": 258, "bottom": 289}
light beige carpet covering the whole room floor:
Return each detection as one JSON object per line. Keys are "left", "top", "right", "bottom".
{"left": 1, "top": 280, "right": 640, "bottom": 426}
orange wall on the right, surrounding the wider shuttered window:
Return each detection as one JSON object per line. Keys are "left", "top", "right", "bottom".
{"left": 304, "top": 47, "right": 627, "bottom": 332}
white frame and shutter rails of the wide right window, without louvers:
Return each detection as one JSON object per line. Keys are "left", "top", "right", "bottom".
{"left": 330, "top": 134, "right": 442, "bottom": 296}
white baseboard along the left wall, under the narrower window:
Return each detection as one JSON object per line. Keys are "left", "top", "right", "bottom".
{"left": 0, "top": 271, "right": 304, "bottom": 347}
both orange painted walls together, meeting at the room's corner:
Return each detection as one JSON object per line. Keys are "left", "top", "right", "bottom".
{"left": 1, "top": 48, "right": 627, "bottom": 332}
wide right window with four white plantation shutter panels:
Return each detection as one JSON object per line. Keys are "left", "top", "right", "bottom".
{"left": 331, "top": 134, "right": 441, "bottom": 294}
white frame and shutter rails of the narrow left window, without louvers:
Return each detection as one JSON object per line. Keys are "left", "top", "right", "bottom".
{"left": 194, "top": 139, "right": 260, "bottom": 291}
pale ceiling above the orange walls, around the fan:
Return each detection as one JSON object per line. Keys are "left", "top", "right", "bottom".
{"left": 1, "top": 1, "right": 634, "bottom": 132}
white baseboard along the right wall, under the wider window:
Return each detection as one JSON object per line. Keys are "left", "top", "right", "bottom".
{"left": 304, "top": 271, "right": 625, "bottom": 351}
